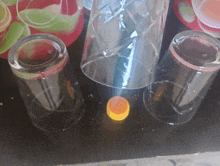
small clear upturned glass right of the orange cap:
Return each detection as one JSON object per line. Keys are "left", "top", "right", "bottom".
{"left": 144, "top": 30, "right": 220, "bottom": 125}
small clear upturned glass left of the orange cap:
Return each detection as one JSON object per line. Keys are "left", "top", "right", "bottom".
{"left": 8, "top": 34, "right": 84, "bottom": 131}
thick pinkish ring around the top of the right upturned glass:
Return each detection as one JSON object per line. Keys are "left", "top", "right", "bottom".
{"left": 169, "top": 30, "right": 220, "bottom": 72}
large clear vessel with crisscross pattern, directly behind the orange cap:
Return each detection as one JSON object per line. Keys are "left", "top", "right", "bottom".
{"left": 81, "top": 0, "right": 169, "bottom": 89}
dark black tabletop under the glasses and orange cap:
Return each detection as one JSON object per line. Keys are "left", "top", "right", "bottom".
{"left": 0, "top": 1, "right": 220, "bottom": 165}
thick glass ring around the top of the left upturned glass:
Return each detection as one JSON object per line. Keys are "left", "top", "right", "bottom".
{"left": 8, "top": 34, "right": 68, "bottom": 79}
